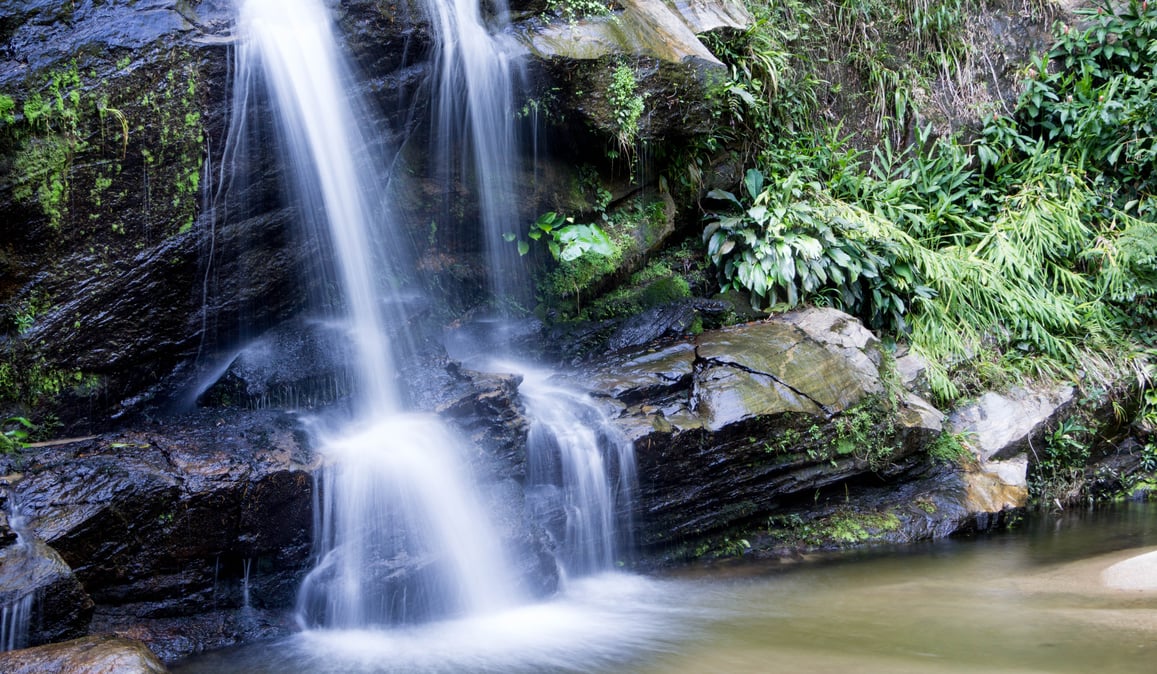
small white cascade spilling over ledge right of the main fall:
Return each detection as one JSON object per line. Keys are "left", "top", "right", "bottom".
{"left": 518, "top": 370, "right": 638, "bottom": 577}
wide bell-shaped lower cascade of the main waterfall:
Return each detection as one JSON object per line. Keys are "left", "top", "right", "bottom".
{"left": 299, "top": 414, "right": 514, "bottom": 628}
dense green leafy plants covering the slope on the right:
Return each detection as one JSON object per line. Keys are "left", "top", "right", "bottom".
{"left": 703, "top": 0, "right": 1157, "bottom": 398}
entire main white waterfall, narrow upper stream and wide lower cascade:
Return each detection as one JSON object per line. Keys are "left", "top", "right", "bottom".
{"left": 234, "top": 0, "right": 515, "bottom": 628}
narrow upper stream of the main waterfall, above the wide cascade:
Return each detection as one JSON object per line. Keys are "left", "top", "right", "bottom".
{"left": 238, "top": 0, "right": 397, "bottom": 415}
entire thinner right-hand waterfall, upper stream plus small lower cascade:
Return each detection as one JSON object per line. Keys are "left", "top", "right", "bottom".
{"left": 426, "top": 0, "right": 634, "bottom": 575}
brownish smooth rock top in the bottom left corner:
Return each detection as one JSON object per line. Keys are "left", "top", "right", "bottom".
{"left": 0, "top": 635, "right": 168, "bottom": 674}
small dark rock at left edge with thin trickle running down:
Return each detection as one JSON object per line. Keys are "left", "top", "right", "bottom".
{"left": 0, "top": 536, "right": 93, "bottom": 647}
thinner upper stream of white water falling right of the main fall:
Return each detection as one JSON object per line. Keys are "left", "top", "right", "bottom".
{"left": 423, "top": 0, "right": 526, "bottom": 299}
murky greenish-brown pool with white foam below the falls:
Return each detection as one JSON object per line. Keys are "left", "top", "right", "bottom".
{"left": 174, "top": 504, "right": 1157, "bottom": 674}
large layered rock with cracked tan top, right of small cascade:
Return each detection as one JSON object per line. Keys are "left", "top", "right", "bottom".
{"left": 574, "top": 309, "right": 942, "bottom": 556}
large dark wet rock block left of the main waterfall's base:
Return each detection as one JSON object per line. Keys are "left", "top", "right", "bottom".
{"left": 7, "top": 412, "right": 315, "bottom": 661}
